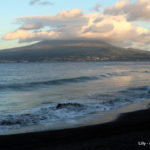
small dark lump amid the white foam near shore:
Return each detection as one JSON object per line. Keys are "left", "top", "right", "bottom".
{"left": 56, "top": 103, "right": 83, "bottom": 109}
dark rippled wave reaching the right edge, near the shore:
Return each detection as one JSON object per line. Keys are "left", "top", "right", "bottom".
{"left": 88, "top": 85, "right": 150, "bottom": 105}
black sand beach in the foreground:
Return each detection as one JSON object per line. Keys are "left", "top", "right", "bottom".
{"left": 0, "top": 109, "right": 150, "bottom": 150}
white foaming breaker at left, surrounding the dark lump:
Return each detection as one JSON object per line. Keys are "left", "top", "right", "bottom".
{"left": 0, "top": 101, "right": 108, "bottom": 133}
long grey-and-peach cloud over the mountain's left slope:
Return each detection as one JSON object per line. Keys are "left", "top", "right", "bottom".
{"left": 3, "top": 9, "right": 88, "bottom": 42}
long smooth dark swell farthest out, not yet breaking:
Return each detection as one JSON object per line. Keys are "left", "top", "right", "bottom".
{"left": 0, "top": 72, "right": 142, "bottom": 90}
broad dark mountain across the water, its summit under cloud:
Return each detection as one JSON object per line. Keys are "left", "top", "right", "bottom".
{"left": 0, "top": 40, "right": 150, "bottom": 62}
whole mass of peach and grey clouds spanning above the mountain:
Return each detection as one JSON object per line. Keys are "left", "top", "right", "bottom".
{"left": 3, "top": 0, "right": 150, "bottom": 49}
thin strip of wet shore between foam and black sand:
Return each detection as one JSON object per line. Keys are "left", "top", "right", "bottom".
{"left": 3, "top": 99, "right": 150, "bottom": 136}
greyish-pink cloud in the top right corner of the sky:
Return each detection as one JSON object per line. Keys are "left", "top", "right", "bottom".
{"left": 104, "top": 0, "right": 150, "bottom": 22}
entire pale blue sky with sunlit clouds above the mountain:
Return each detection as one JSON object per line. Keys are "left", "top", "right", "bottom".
{"left": 0, "top": 0, "right": 150, "bottom": 51}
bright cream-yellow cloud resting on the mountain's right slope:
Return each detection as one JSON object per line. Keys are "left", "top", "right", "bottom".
{"left": 81, "top": 15, "right": 150, "bottom": 47}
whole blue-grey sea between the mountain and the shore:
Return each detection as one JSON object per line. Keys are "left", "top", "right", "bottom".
{"left": 0, "top": 61, "right": 150, "bottom": 134}
